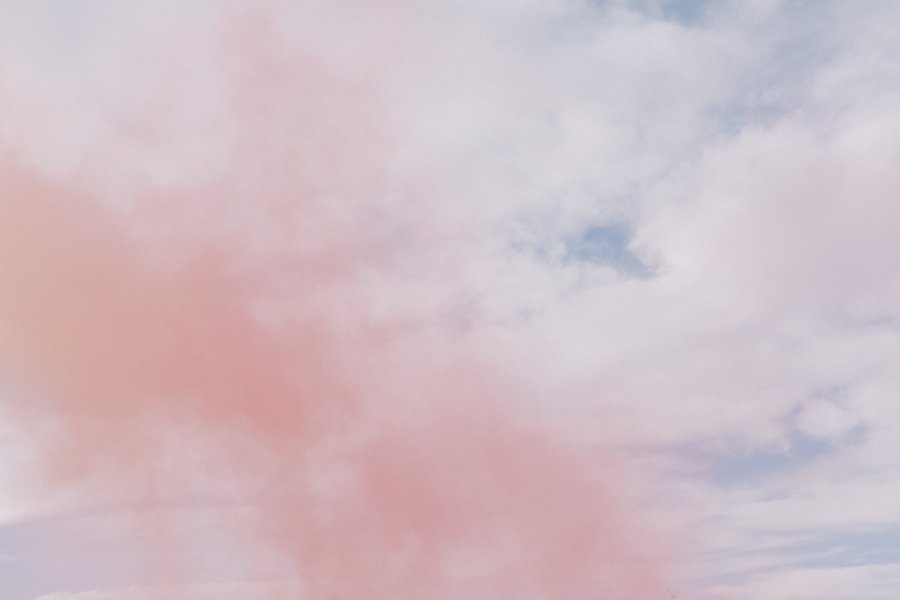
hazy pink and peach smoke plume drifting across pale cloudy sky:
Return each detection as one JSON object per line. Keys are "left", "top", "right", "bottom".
{"left": 0, "top": 2, "right": 684, "bottom": 600}
